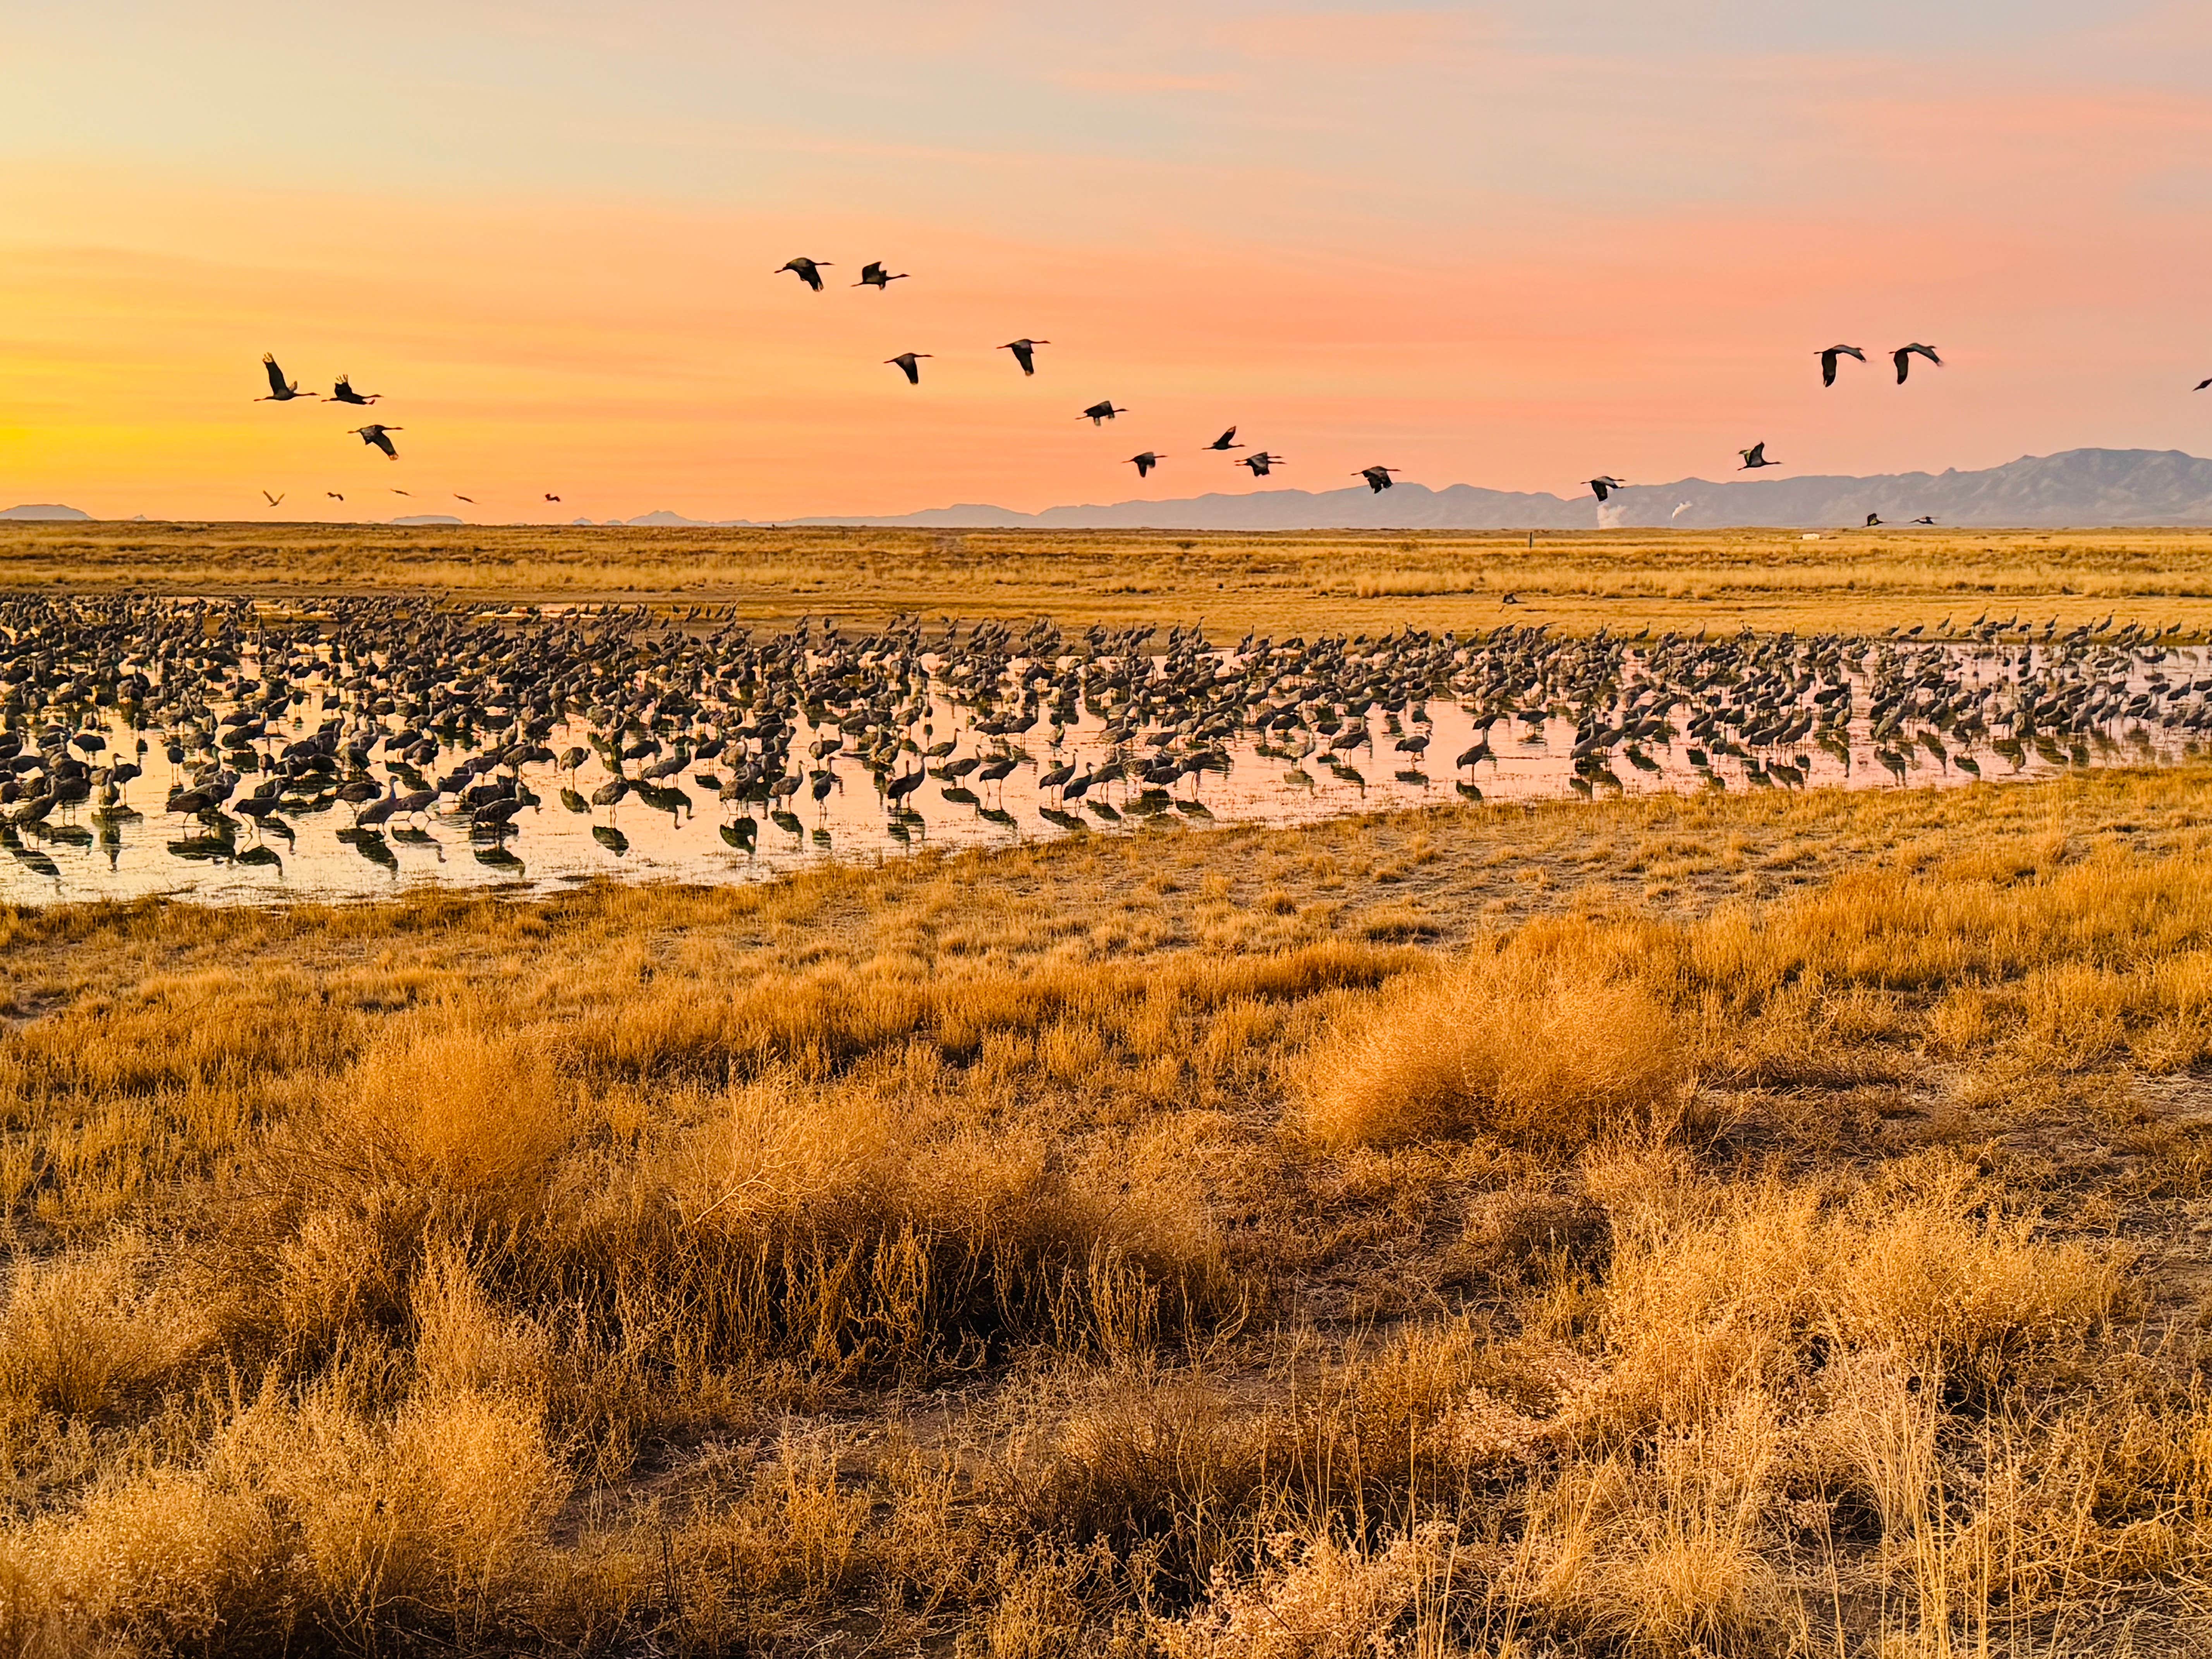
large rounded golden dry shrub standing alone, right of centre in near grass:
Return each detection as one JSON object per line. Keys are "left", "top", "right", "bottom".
{"left": 1305, "top": 942, "right": 1686, "bottom": 1148}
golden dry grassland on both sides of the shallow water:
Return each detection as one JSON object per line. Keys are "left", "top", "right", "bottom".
{"left": 0, "top": 535, "right": 2212, "bottom": 1659}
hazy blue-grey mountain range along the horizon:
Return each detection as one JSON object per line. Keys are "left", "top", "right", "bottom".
{"left": 21, "top": 449, "right": 2212, "bottom": 531}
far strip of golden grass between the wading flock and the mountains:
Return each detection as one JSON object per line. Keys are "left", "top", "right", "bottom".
{"left": 13, "top": 522, "right": 2212, "bottom": 639}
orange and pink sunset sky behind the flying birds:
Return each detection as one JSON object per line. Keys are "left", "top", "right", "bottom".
{"left": 0, "top": 0, "right": 2212, "bottom": 520}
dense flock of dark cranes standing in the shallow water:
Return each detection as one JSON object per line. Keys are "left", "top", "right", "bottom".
{"left": 0, "top": 595, "right": 2212, "bottom": 876}
